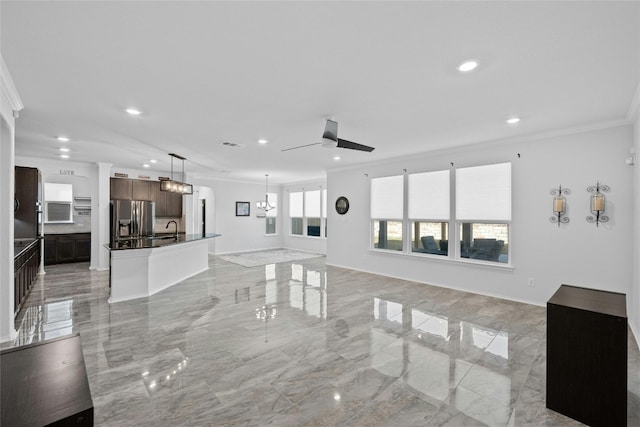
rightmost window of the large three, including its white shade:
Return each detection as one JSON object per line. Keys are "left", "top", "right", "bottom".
{"left": 456, "top": 163, "right": 511, "bottom": 263}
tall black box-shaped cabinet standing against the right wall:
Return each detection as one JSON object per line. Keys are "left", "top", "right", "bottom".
{"left": 547, "top": 285, "right": 627, "bottom": 426}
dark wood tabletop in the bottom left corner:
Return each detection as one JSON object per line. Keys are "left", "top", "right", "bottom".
{"left": 0, "top": 335, "right": 93, "bottom": 426}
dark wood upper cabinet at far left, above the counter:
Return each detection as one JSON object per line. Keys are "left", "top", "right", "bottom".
{"left": 13, "top": 166, "right": 42, "bottom": 239}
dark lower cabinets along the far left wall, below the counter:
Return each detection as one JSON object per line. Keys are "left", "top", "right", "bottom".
{"left": 13, "top": 239, "right": 40, "bottom": 316}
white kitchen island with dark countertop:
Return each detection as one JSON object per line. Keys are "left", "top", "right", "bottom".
{"left": 105, "top": 233, "right": 220, "bottom": 303}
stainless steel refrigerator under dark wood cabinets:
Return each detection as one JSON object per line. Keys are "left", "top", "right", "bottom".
{"left": 111, "top": 200, "right": 156, "bottom": 242}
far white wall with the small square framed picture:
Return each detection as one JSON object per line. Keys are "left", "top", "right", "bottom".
{"left": 194, "top": 179, "right": 282, "bottom": 254}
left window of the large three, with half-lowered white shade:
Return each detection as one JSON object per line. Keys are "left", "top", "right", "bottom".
{"left": 371, "top": 175, "right": 404, "bottom": 251}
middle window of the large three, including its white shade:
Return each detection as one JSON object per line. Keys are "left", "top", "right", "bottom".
{"left": 408, "top": 170, "right": 450, "bottom": 256}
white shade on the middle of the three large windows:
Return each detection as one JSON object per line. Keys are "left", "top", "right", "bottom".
{"left": 409, "top": 170, "right": 450, "bottom": 220}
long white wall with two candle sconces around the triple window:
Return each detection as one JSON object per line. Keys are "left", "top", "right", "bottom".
{"left": 327, "top": 125, "right": 638, "bottom": 315}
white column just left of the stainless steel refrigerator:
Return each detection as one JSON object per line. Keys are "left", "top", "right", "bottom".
{"left": 90, "top": 162, "right": 111, "bottom": 270}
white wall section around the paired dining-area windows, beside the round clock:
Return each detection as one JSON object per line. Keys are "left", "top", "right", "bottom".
{"left": 280, "top": 181, "right": 328, "bottom": 254}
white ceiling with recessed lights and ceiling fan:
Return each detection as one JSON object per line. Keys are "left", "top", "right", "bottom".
{"left": 0, "top": 0, "right": 640, "bottom": 183}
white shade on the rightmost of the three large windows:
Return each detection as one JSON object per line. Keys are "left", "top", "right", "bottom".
{"left": 456, "top": 163, "right": 511, "bottom": 221}
